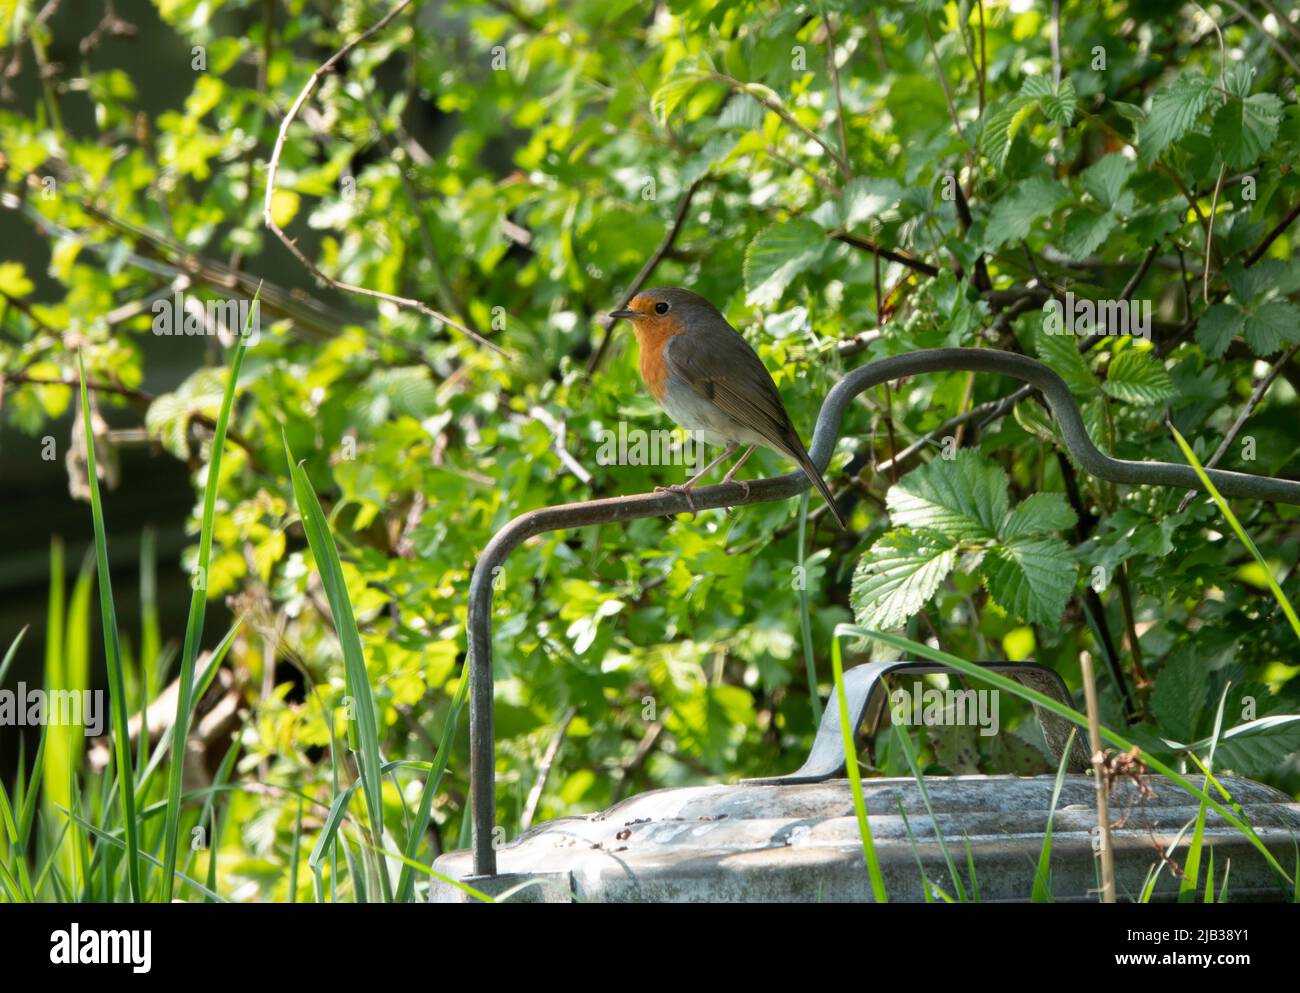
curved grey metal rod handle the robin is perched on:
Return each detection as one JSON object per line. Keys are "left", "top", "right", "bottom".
{"left": 465, "top": 348, "right": 1300, "bottom": 876}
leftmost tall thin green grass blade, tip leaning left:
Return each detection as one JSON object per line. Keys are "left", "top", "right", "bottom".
{"left": 78, "top": 355, "right": 144, "bottom": 902}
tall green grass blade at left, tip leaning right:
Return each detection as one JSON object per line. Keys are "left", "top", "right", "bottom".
{"left": 163, "top": 319, "right": 250, "bottom": 903}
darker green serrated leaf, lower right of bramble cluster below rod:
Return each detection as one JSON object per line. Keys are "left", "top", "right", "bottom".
{"left": 980, "top": 535, "right": 1076, "bottom": 624}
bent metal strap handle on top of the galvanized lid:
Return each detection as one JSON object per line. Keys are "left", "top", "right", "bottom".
{"left": 741, "top": 660, "right": 1088, "bottom": 786}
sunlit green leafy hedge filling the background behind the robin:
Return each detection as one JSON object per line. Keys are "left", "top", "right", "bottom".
{"left": 0, "top": 0, "right": 1300, "bottom": 899}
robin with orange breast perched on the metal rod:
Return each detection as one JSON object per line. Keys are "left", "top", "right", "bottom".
{"left": 610, "top": 286, "right": 849, "bottom": 530}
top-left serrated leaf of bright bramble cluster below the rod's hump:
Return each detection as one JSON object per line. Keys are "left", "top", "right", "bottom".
{"left": 885, "top": 448, "right": 1009, "bottom": 539}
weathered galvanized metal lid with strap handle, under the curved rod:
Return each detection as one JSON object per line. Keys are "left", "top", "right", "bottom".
{"left": 430, "top": 662, "right": 1300, "bottom": 902}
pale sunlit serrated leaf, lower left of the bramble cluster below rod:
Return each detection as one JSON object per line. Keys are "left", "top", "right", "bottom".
{"left": 849, "top": 530, "right": 957, "bottom": 629}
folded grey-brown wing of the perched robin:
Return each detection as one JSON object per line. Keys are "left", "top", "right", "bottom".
{"left": 664, "top": 322, "right": 803, "bottom": 454}
